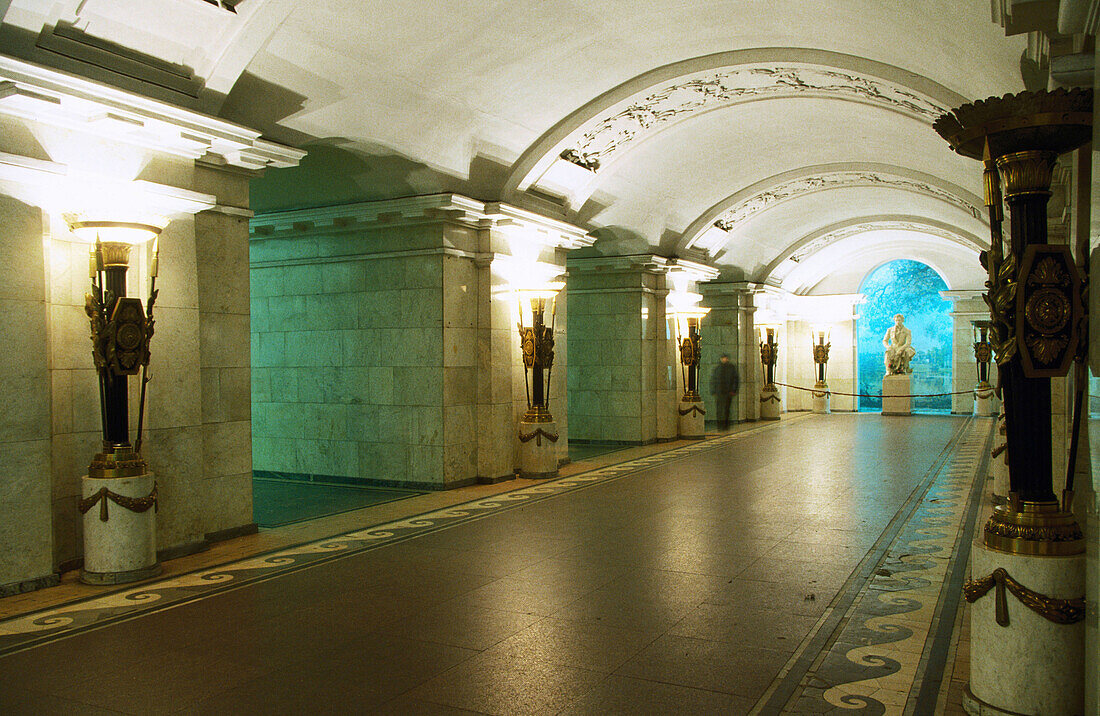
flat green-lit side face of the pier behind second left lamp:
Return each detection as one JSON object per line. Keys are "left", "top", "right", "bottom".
{"left": 252, "top": 235, "right": 448, "bottom": 486}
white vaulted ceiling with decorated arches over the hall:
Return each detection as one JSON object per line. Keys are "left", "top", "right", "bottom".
{"left": 0, "top": 0, "right": 1026, "bottom": 293}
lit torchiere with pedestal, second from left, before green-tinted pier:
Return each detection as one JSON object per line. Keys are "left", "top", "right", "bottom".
{"left": 515, "top": 282, "right": 565, "bottom": 477}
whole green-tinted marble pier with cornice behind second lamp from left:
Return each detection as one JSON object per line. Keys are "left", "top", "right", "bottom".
{"left": 251, "top": 195, "right": 568, "bottom": 489}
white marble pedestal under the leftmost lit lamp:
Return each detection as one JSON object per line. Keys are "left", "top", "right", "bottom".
{"left": 80, "top": 473, "right": 161, "bottom": 584}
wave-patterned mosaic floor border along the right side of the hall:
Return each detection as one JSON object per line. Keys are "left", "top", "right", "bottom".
{"left": 752, "top": 418, "right": 992, "bottom": 715}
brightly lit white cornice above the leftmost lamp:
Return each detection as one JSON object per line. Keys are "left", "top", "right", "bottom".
{"left": 0, "top": 55, "right": 306, "bottom": 169}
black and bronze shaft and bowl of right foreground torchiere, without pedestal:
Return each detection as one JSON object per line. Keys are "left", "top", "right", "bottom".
{"left": 934, "top": 89, "right": 1092, "bottom": 554}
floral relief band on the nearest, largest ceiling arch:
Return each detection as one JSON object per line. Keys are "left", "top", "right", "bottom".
{"left": 559, "top": 63, "right": 950, "bottom": 172}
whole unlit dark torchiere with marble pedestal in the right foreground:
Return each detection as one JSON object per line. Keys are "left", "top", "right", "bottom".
{"left": 933, "top": 89, "right": 1092, "bottom": 714}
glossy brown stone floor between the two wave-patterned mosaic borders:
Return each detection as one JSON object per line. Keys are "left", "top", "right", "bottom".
{"left": 0, "top": 415, "right": 969, "bottom": 714}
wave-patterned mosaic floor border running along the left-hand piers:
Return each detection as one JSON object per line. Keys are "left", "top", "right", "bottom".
{"left": 0, "top": 414, "right": 812, "bottom": 656}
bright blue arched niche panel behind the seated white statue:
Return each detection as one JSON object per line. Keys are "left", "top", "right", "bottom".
{"left": 857, "top": 258, "right": 952, "bottom": 412}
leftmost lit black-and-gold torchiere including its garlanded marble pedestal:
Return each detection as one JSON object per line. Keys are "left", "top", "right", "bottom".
{"left": 69, "top": 220, "right": 162, "bottom": 584}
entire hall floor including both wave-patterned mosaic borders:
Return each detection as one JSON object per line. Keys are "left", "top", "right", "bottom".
{"left": 0, "top": 415, "right": 991, "bottom": 714}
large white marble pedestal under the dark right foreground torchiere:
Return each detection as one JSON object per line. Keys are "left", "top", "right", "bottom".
{"left": 964, "top": 538, "right": 1085, "bottom": 716}
